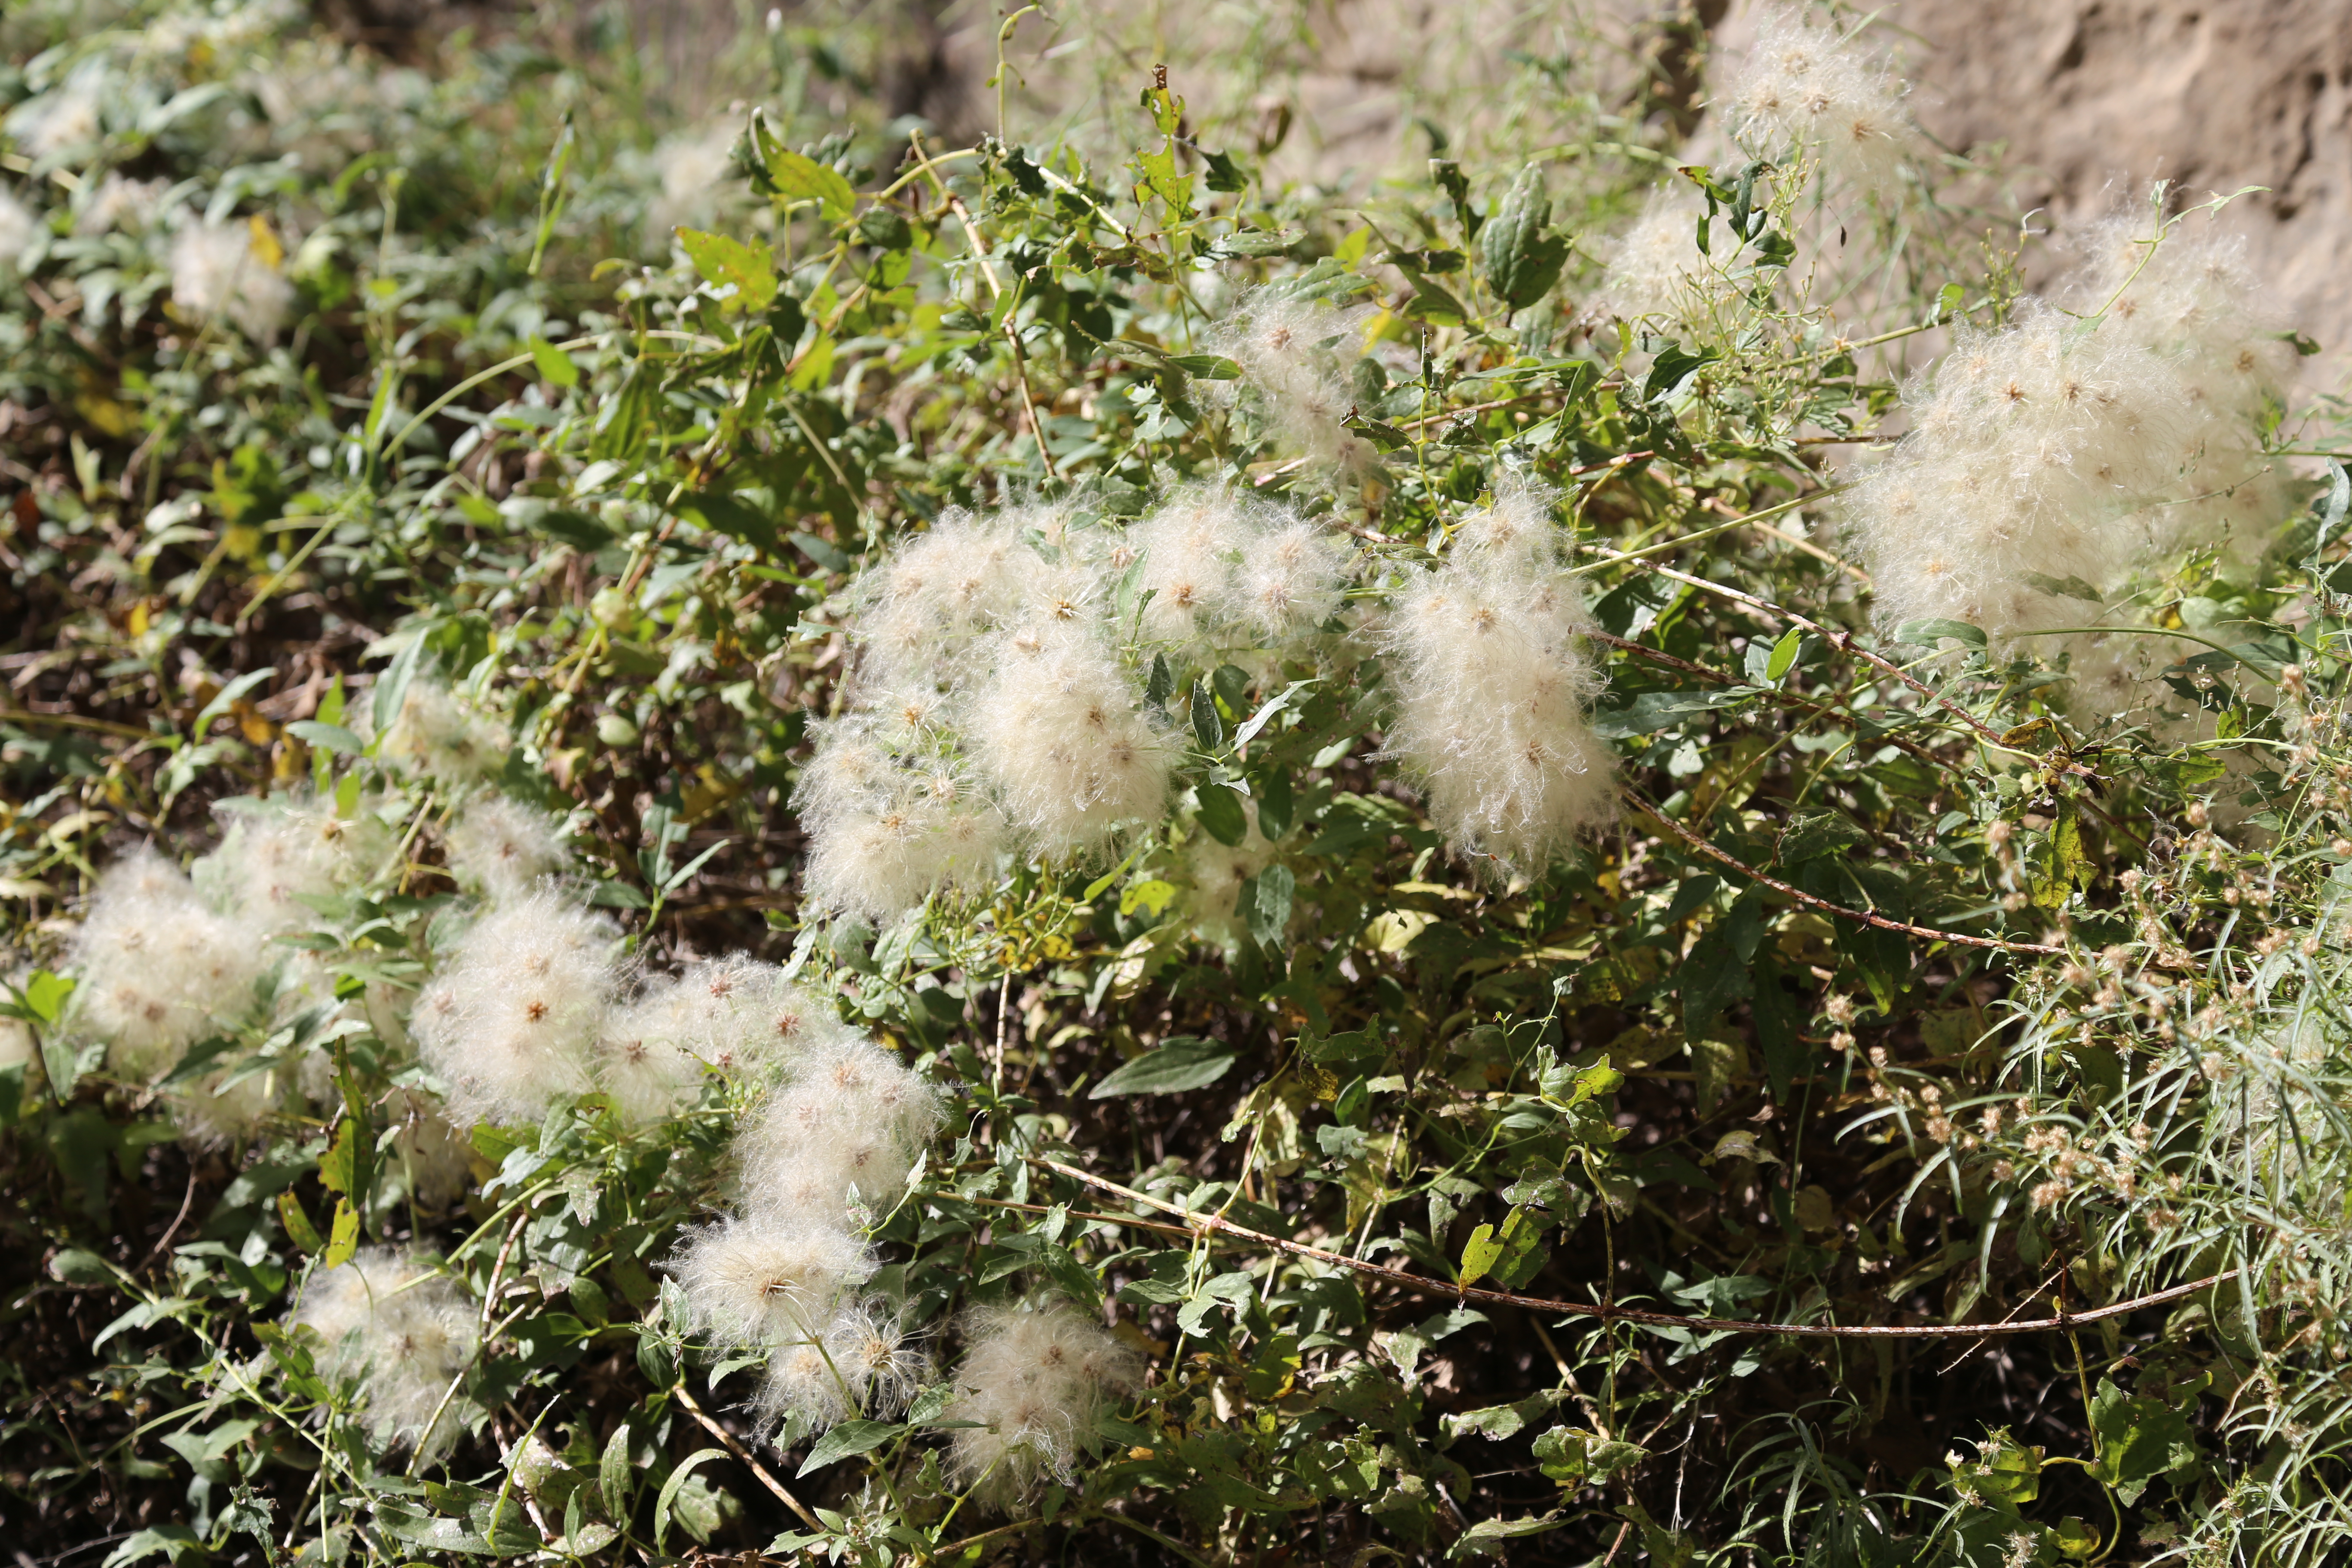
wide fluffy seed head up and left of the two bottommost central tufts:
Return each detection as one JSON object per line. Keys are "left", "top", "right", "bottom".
{"left": 671, "top": 1216, "right": 875, "bottom": 1349}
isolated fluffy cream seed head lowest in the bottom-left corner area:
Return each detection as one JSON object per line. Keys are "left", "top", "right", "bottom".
{"left": 292, "top": 1246, "right": 475, "bottom": 1458}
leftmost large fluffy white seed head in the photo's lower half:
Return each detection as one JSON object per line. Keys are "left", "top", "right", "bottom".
{"left": 70, "top": 848, "right": 273, "bottom": 1077}
